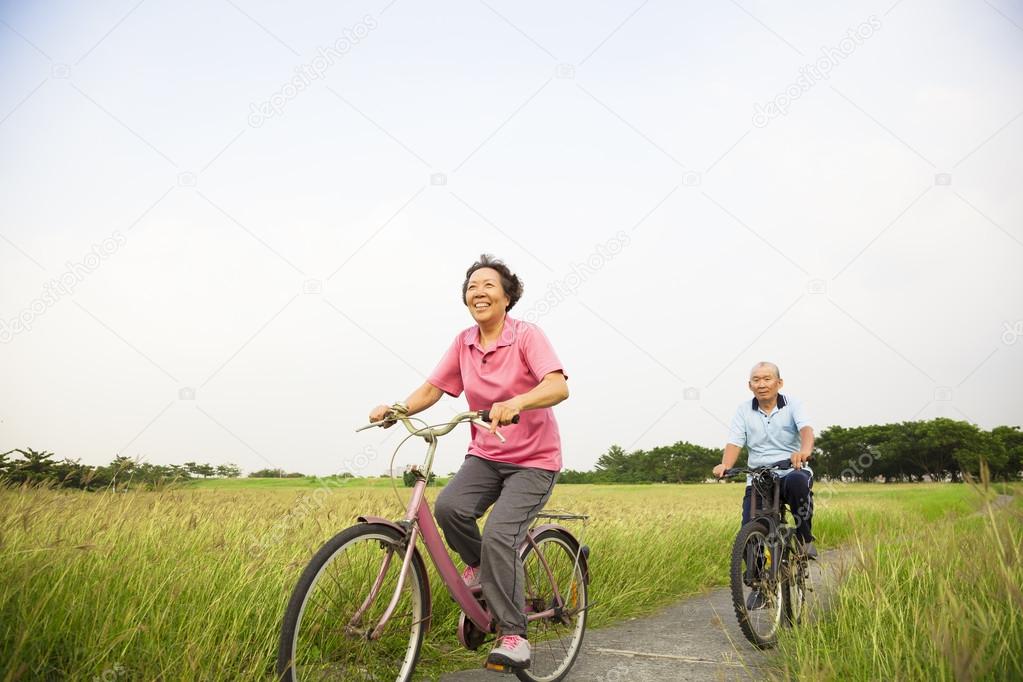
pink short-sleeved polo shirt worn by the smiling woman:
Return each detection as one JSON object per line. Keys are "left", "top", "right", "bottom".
{"left": 428, "top": 317, "right": 563, "bottom": 471}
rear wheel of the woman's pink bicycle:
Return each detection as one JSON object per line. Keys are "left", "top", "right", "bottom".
{"left": 515, "top": 529, "right": 589, "bottom": 682}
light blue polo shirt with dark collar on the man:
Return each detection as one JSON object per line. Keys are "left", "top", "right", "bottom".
{"left": 728, "top": 394, "right": 813, "bottom": 486}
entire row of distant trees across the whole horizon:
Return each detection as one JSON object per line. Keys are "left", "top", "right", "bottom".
{"left": 0, "top": 418, "right": 1023, "bottom": 490}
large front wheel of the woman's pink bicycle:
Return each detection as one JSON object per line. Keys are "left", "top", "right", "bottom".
{"left": 277, "top": 524, "right": 430, "bottom": 682}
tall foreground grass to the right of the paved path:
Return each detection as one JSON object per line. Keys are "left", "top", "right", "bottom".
{"left": 775, "top": 482, "right": 1023, "bottom": 681}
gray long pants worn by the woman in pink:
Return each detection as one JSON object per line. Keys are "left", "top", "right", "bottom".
{"left": 434, "top": 455, "right": 558, "bottom": 636}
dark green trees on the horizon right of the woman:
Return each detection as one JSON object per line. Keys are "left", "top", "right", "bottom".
{"left": 559, "top": 418, "right": 1023, "bottom": 484}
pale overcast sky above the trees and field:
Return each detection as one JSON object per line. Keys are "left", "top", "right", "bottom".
{"left": 0, "top": 0, "right": 1023, "bottom": 474}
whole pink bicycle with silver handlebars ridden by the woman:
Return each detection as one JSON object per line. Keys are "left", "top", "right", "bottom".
{"left": 277, "top": 409, "right": 589, "bottom": 682}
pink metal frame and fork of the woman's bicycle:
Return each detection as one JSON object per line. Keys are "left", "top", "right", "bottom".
{"left": 349, "top": 415, "right": 588, "bottom": 639}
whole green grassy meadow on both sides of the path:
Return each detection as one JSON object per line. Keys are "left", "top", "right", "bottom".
{"left": 0, "top": 479, "right": 1023, "bottom": 680}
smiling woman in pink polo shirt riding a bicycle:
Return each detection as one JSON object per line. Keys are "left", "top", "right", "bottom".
{"left": 369, "top": 255, "right": 569, "bottom": 668}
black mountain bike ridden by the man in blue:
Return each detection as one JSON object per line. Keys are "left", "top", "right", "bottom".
{"left": 722, "top": 459, "right": 811, "bottom": 649}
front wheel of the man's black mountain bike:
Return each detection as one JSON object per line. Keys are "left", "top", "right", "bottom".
{"left": 731, "top": 521, "right": 784, "bottom": 649}
